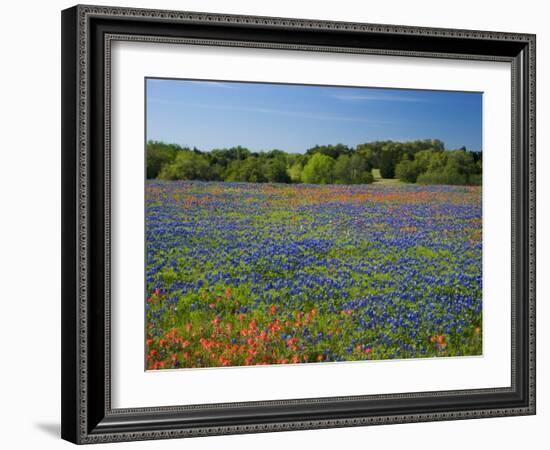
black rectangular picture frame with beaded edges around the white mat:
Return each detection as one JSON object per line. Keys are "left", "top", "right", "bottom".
{"left": 61, "top": 5, "right": 535, "bottom": 444}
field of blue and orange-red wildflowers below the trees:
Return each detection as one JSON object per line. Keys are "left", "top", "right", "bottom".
{"left": 145, "top": 180, "right": 482, "bottom": 369}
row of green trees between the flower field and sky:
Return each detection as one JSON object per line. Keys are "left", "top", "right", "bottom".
{"left": 146, "top": 139, "right": 482, "bottom": 185}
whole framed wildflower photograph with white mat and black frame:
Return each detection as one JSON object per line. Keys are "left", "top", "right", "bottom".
{"left": 62, "top": 6, "right": 535, "bottom": 444}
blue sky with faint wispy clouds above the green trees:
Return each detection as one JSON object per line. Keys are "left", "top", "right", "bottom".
{"left": 146, "top": 78, "right": 482, "bottom": 153}
